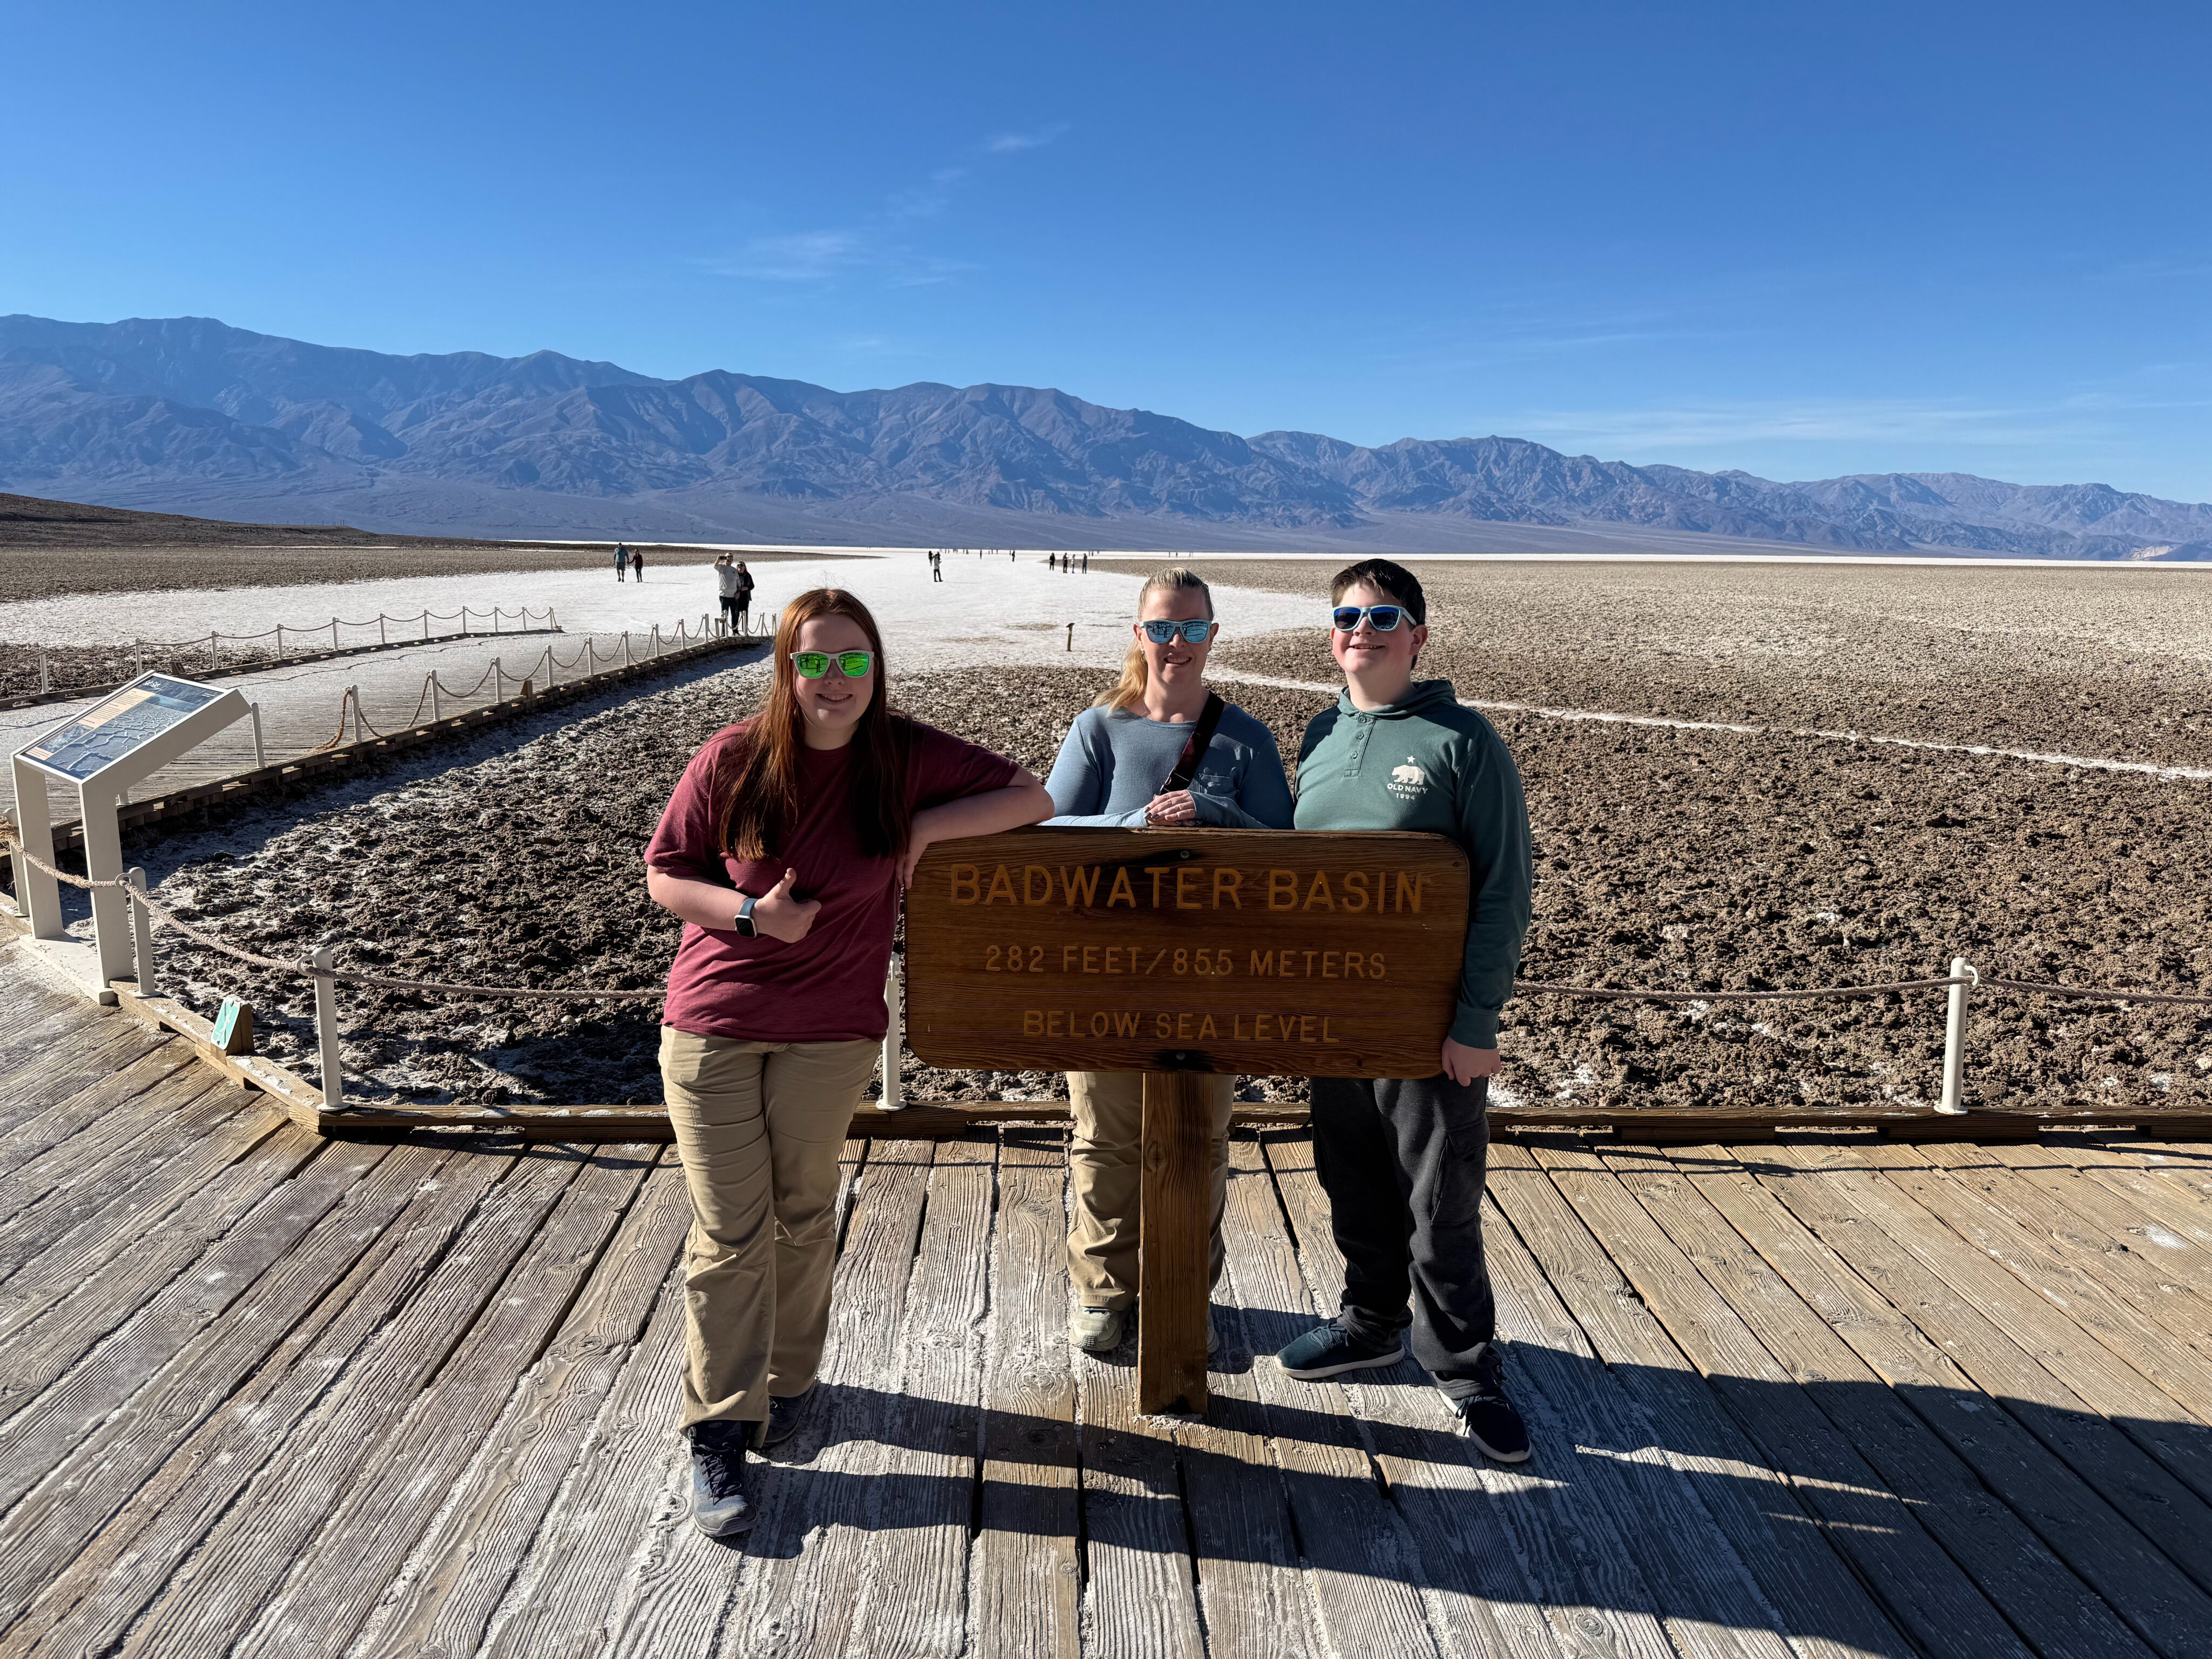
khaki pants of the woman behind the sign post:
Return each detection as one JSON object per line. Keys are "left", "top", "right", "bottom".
{"left": 1068, "top": 1070, "right": 1237, "bottom": 1312}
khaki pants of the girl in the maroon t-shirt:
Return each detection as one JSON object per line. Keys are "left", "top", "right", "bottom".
{"left": 662, "top": 1027, "right": 880, "bottom": 1427}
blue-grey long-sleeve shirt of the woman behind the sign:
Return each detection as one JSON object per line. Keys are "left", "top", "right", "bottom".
{"left": 1044, "top": 704, "right": 1292, "bottom": 830}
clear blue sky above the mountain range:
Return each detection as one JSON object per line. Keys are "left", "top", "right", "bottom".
{"left": 13, "top": 0, "right": 2212, "bottom": 500}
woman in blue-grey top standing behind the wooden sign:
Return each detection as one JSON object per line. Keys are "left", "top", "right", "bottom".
{"left": 1044, "top": 569, "right": 1292, "bottom": 1352}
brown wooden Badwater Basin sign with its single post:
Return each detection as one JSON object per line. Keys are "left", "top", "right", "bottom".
{"left": 907, "top": 830, "right": 1469, "bottom": 1411}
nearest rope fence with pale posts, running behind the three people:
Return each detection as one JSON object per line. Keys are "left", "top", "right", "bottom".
{"left": 6, "top": 843, "right": 2212, "bottom": 1117}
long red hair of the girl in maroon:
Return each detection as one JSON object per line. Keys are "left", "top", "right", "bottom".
{"left": 719, "top": 589, "right": 914, "bottom": 858}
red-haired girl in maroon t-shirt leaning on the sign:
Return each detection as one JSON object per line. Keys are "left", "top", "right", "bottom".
{"left": 646, "top": 589, "right": 1053, "bottom": 1537}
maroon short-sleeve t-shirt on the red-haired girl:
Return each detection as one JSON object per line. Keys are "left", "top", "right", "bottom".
{"left": 646, "top": 721, "right": 1017, "bottom": 1042}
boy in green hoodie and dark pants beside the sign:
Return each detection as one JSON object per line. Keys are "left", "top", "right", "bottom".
{"left": 1278, "top": 559, "right": 1530, "bottom": 1462}
